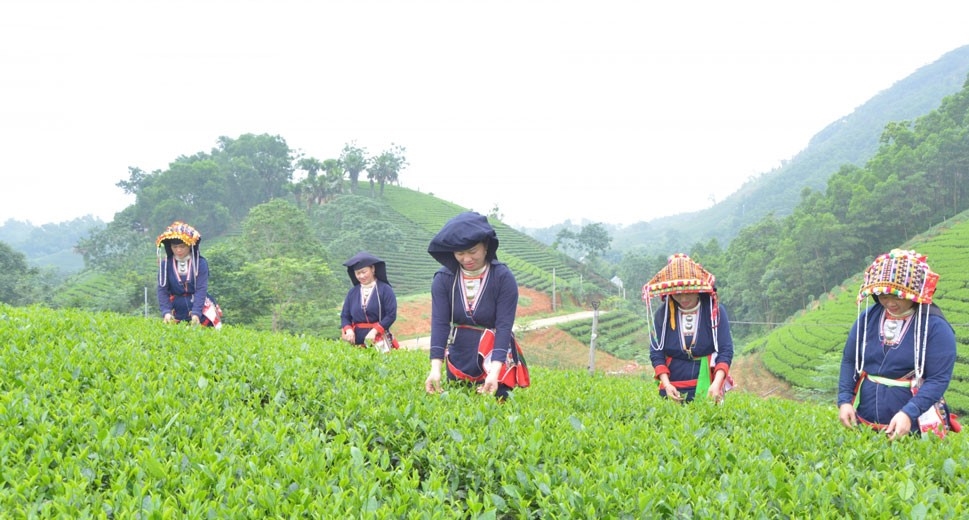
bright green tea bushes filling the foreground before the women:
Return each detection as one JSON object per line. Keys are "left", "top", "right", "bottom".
{"left": 0, "top": 305, "right": 969, "bottom": 518}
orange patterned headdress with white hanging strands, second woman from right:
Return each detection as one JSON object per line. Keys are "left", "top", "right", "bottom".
{"left": 643, "top": 253, "right": 720, "bottom": 351}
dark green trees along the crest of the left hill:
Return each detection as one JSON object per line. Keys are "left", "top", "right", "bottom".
{"left": 107, "top": 134, "right": 408, "bottom": 241}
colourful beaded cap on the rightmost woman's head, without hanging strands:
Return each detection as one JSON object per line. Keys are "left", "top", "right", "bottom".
{"left": 858, "top": 249, "right": 939, "bottom": 303}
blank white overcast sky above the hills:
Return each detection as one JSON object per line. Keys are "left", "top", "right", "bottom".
{"left": 0, "top": 0, "right": 969, "bottom": 227}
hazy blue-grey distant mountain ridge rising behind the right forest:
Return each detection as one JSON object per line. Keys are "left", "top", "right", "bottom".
{"left": 604, "top": 46, "right": 969, "bottom": 253}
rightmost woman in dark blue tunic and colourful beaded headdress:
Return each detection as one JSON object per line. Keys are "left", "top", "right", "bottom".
{"left": 838, "top": 249, "right": 960, "bottom": 439}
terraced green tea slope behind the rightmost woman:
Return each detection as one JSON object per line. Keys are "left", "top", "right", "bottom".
{"left": 750, "top": 208, "right": 969, "bottom": 414}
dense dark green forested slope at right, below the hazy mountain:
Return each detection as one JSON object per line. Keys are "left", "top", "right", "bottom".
{"left": 619, "top": 64, "right": 969, "bottom": 336}
